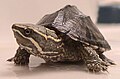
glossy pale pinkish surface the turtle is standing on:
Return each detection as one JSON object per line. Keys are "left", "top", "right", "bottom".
{"left": 0, "top": 25, "right": 120, "bottom": 79}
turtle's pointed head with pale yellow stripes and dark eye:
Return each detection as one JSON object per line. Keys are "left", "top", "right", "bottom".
{"left": 12, "top": 24, "right": 47, "bottom": 54}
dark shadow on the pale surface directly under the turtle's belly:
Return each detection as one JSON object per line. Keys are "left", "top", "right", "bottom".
{"left": 31, "top": 62, "right": 86, "bottom": 72}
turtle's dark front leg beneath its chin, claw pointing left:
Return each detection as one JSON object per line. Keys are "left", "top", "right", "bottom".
{"left": 7, "top": 47, "right": 30, "bottom": 65}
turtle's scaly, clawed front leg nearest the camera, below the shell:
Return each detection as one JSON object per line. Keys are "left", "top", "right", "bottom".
{"left": 81, "top": 46, "right": 108, "bottom": 72}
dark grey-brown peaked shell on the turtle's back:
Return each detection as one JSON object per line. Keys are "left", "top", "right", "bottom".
{"left": 37, "top": 5, "right": 111, "bottom": 51}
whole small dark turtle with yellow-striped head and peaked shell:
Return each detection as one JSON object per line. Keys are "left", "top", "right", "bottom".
{"left": 8, "top": 5, "right": 115, "bottom": 72}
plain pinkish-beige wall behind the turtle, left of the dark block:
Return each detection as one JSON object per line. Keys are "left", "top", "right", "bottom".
{"left": 0, "top": 0, "right": 98, "bottom": 43}
